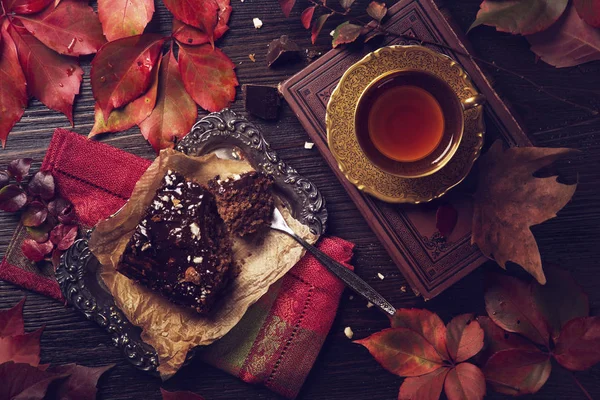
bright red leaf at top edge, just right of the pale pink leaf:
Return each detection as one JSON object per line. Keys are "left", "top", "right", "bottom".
{"left": 163, "top": 0, "right": 219, "bottom": 44}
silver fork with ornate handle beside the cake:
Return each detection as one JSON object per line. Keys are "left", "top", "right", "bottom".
{"left": 271, "top": 208, "right": 396, "bottom": 315}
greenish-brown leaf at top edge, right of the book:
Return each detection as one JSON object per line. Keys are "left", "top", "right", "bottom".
{"left": 469, "top": 0, "right": 569, "bottom": 35}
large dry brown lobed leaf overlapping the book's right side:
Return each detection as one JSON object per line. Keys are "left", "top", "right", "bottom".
{"left": 471, "top": 140, "right": 577, "bottom": 284}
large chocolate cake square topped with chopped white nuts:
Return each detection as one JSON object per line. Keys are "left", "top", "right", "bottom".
{"left": 117, "top": 171, "right": 232, "bottom": 314}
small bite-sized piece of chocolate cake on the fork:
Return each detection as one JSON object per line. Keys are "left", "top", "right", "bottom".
{"left": 208, "top": 171, "right": 275, "bottom": 236}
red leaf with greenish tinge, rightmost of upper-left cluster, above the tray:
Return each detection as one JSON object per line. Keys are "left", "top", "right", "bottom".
{"left": 179, "top": 45, "right": 238, "bottom": 112}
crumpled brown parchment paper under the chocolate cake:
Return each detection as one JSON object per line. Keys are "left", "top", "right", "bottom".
{"left": 90, "top": 150, "right": 317, "bottom": 380}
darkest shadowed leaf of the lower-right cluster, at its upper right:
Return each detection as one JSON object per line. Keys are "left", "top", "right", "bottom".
{"left": 532, "top": 265, "right": 590, "bottom": 341}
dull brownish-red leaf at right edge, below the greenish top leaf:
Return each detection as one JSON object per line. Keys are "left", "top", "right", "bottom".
{"left": 527, "top": 7, "right": 600, "bottom": 68}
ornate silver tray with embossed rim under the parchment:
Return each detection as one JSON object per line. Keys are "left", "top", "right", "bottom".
{"left": 56, "top": 109, "right": 327, "bottom": 373}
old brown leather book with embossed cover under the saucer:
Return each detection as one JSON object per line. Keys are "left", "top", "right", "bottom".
{"left": 280, "top": 0, "right": 530, "bottom": 299}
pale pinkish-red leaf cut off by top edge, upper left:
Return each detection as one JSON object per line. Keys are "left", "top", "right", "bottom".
{"left": 98, "top": 0, "right": 154, "bottom": 41}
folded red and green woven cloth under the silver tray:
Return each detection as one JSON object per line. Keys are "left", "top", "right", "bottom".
{"left": 0, "top": 129, "right": 354, "bottom": 399}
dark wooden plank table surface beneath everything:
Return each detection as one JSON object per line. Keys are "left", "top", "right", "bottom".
{"left": 0, "top": 0, "right": 600, "bottom": 400}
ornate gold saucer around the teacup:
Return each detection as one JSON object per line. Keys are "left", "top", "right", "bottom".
{"left": 325, "top": 46, "right": 485, "bottom": 204}
